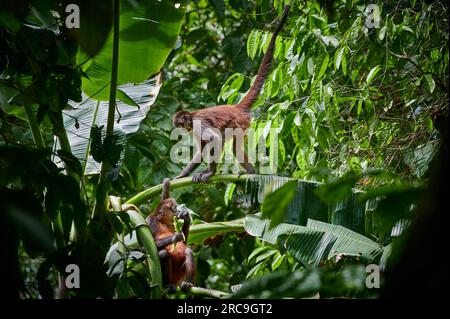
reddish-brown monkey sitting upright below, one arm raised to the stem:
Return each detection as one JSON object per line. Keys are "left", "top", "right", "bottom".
{"left": 146, "top": 178, "right": 195, "bottom": 293}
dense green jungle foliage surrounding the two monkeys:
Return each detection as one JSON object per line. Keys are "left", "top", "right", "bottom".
{"left": 0, "top": 0, "right": 449, "bottom": 298}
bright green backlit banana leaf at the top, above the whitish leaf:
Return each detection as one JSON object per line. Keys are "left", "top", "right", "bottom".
{"left": 77, "top": 0, "right": 184, "bottom": 100}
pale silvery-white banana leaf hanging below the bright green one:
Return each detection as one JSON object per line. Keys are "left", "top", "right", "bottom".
{"left": 55, "top": 75, "right": 161, "bottom": 174}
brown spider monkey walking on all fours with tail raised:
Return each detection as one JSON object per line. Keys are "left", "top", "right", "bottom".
{"left": 173, "top": 6, "right": 289, "bottom": 183}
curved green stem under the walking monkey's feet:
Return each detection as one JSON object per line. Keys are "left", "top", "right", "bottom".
{"left": 125, "top": 174, "right": 251, "bottom": 205}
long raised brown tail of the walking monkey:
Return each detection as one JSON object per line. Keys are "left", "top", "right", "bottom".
{"left": 237, "top": 6, "right": 290, "bottom": 108}
